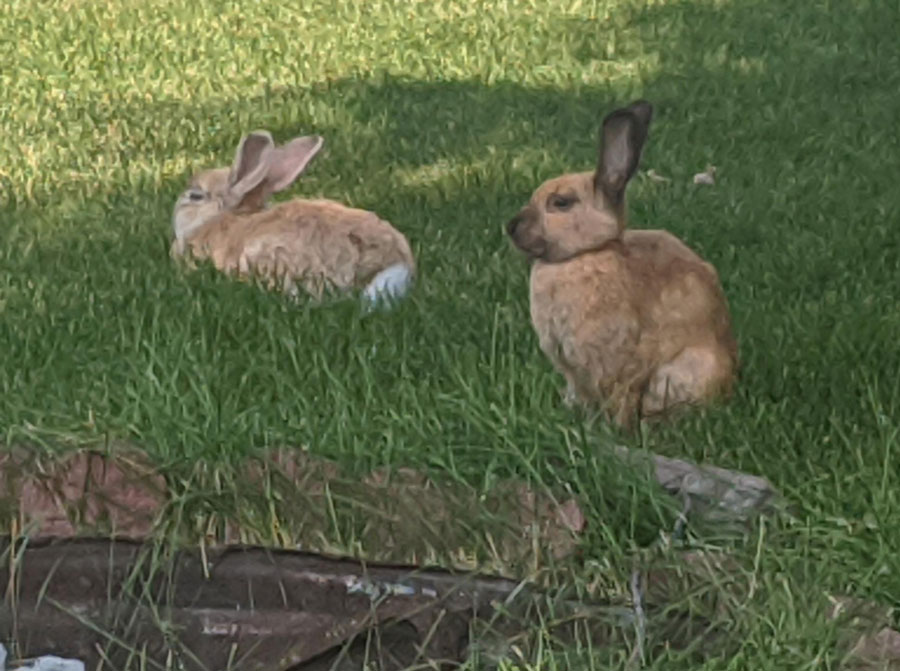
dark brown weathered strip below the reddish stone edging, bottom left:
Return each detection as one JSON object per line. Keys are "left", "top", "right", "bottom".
{"left": 0, "top": 538, "right": 519, "bottom": 671}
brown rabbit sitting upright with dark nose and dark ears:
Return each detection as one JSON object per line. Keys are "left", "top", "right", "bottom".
{"left": 507, "top": 100, "right": 737, "bottom": 426}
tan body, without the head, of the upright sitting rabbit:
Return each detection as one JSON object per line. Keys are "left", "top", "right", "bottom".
{"left": 531, "top": 230, "right": 737, "bottom": 424}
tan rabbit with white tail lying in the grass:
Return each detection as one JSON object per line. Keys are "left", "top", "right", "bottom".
{"left": 170, "top": 130, "right": 415, "bottom": 307}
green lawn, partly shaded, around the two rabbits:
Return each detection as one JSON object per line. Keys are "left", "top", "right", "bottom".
{"left": 0, "top": 0, "right": 900, "bottom": 669}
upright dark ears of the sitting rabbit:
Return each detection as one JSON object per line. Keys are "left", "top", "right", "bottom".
{"left": 594, "top": 100, "right": 653, "bottom": 205}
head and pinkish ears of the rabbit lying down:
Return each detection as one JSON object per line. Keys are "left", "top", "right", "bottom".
{"left": 172, "top": 130, "right": 324, "bottom": 251}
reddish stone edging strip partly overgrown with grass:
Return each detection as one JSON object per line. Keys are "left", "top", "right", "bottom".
{"left": 0, "top": 448, "right": 585, "bottom": 573}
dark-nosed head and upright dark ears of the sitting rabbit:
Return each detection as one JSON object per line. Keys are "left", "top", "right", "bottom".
{"left": 506, "top": 100, "right": 653, "bottom": 263}
